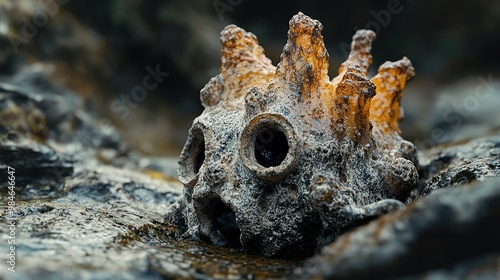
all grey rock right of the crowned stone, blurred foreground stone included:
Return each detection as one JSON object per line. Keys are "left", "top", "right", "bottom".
{"left": 295, "top": 131, "right": 500, "bottom": 279}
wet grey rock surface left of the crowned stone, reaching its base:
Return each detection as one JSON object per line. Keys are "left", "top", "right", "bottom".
{"left": 0, "top": 66, "right": 296, "bottom": 279}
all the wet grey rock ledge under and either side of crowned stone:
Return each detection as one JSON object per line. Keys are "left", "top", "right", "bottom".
{"left": 0, "top": 66, "right": 500, "bottom": 279}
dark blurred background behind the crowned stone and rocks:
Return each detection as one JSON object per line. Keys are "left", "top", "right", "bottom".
{"left": 0, "top": 0, "right": 500, "bottom": 156}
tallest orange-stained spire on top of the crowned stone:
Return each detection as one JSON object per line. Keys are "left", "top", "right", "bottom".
{"left": 276, "top": 13, "right": 329, "bottom": 100}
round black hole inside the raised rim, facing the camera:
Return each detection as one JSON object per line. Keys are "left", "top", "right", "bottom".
{"left": 254, "top": 127, "right": 288, "bottom": 167}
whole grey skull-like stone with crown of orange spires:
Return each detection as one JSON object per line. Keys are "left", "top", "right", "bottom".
{"left": 174, "top": 13, "right": 418, "bottom": 255}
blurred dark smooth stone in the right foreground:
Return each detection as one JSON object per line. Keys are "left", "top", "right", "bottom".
{"left": 297, "top": 179, "right": 500, "bottom": 279}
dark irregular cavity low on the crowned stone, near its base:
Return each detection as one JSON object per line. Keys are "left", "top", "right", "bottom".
{"left": 212, "top": 199, "right": 241, "bottom": 248}
